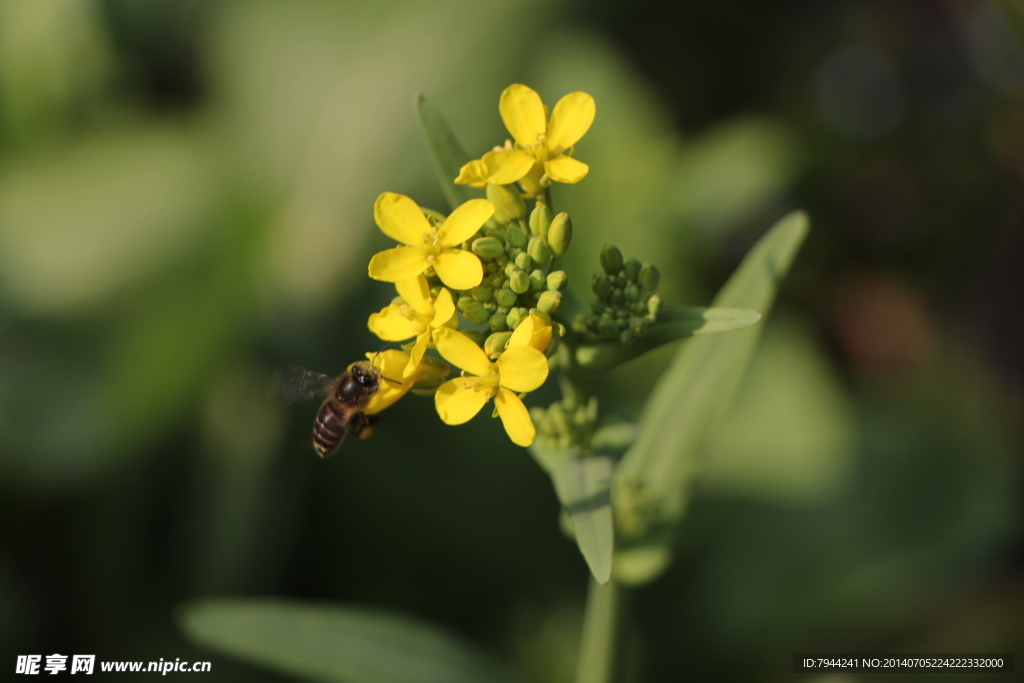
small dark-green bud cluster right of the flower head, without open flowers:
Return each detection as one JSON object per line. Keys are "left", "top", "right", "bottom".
{"left": 572, "top": 245, "right": 662, "bottom": 344}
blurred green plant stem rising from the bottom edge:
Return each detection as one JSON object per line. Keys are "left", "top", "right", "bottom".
{"left": 575, "top": 577, "right": 624, "bottom": 683}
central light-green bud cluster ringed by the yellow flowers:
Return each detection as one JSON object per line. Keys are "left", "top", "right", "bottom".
{"left": 456, "top": 184, "right": 572, "bottom": 358}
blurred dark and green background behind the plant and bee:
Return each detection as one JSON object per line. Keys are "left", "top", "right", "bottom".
{"left": 0, "top": 0, "right": 1024, "bottom": 683}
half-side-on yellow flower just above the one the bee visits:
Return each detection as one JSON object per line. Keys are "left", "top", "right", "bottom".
{"left": 367, "top": 275, "right": 455, "bottom": 377}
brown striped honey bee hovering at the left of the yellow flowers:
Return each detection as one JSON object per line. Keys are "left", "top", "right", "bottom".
{"left": 271, "top": 360, "right": 388, "bottom": 458}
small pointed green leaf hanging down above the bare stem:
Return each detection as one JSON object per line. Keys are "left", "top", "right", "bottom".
{"left": 551, "top": 454, "right": 614, "bottom": 584}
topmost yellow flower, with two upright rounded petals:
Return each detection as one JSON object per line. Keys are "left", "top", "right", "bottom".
{"left": 456, "top": 83, "right": 597, "bottom": 196}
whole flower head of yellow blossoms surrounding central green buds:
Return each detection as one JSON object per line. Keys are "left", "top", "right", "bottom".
{"left": 356, "top": 84, "right": 595, "bottom": 446}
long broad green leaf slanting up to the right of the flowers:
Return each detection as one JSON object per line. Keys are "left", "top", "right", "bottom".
{"left": 614, "top": 212, "right": 808, "bottom": 583}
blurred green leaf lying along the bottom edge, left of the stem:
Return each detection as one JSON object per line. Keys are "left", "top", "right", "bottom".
{"left": 179, "top": 600, "right": 516, "bottom": 683}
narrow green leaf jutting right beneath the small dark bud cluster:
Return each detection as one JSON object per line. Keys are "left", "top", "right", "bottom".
{"left": 577, "top": 306, "right": 761, "bottom": 370}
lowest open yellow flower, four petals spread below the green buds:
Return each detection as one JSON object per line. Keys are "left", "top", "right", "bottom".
{"left": 434, "top": 325, "right": 548, "bottom": 446}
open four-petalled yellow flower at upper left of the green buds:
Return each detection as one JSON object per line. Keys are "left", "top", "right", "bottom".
{"left": 370, "top": 193, "right": 495, "bottom": 290}
